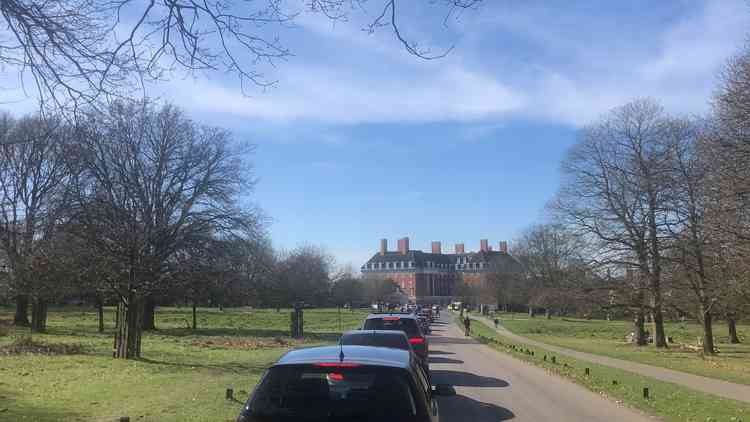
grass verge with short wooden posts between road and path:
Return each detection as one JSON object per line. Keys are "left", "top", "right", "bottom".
{"left": 464, "top": 316, "right": 750, "bottom": 422}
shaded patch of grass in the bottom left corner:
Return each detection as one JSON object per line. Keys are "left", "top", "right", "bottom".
{"left": 0, "top": 385, "right": 84, "bottom": 422}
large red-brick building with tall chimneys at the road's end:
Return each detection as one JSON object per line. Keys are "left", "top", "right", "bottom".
{"left": 361, "top": 237, "right": 520, "bottom": 303}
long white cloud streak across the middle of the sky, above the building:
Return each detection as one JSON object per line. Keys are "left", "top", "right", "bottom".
{"left": 166, "top": 66, "right": 525, "bottom": 123}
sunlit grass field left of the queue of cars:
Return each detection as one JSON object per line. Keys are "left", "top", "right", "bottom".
{"left": 0, "top": 307, "right": 366, "bottom": 422}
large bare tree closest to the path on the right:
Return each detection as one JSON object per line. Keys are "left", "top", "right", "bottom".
{"left": 552, "top": 100, "right": 670, "bottom": 347}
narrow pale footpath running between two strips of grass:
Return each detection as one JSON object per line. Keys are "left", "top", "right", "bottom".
{"left": 474, "top": 317, "right": 750, "bottom": 403}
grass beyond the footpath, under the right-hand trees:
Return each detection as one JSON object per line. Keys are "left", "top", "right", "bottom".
{"left": 490, "top": 314, "right": 750, "bottom": 384}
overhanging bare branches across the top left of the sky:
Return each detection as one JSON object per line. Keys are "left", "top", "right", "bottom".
{"left": 0, "top": 0, "right": 481, "bottom": 106}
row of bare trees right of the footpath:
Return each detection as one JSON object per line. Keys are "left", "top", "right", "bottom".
{"left": 464, "top": 43, "right": 750, "bottom": 354}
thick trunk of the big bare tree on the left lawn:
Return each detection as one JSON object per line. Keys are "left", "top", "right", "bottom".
{"left": 112, "top": 292, "right": 144, "bottom": 359}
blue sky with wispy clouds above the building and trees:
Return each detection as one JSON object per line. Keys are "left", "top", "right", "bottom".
{"left": 0, "top": 0, "right": 750, "bottom": 269}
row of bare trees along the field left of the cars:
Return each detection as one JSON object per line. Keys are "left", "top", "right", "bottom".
{"left": 0, "top": 101, "right": 370, "bottom": 358}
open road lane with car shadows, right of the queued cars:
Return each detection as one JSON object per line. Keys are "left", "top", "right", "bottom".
{"left": 430, "top": 312, "right": 653, "bottom": 422}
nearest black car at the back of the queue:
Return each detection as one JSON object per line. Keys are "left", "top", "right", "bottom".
{"left": 237, "top": 346, "right": 452, "bottom": 422}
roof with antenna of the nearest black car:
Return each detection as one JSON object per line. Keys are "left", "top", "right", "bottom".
{"left": 274, "top": 346, "right": 411, "bottom": 368}
